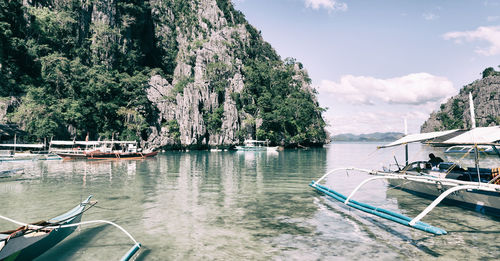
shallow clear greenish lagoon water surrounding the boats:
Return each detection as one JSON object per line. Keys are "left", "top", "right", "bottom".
{"left": 0, "top": 143, "right": 500, "bottom": 260}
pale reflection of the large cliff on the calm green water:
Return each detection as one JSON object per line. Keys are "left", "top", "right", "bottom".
{"left": 142, "top": 149, "right": 326, "bottom": 259}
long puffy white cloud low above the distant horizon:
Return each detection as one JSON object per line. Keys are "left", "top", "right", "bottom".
{"left": 318, "top": 73, "right": 456, "bottom": 105}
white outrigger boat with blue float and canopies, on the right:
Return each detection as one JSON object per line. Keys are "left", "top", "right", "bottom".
{"left": 309, "top": 93, "right": 500, "bottom": 235}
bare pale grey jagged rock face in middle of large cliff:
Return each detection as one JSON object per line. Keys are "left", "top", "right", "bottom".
{"left": 147, "top": 0, "right": 320, "bottom": 147}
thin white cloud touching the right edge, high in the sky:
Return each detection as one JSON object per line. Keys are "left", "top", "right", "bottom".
{"left": 443, "top": 26, "right": 500, "bottom": 56}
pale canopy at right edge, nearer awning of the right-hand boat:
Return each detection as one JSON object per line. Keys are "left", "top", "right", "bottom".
{"left": 441, "top": 126, "right": 500, "bottom": 145}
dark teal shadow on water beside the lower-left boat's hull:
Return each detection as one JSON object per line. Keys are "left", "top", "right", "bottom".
{"left": 37, "top": 225, "right": 106, "bottom": 261}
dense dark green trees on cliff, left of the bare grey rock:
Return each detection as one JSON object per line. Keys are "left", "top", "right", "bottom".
{"left": 0, "top": 0, "right": 156, "bottom": 139}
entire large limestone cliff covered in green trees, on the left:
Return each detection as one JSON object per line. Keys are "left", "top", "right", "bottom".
{"left": 0, "top": 0, "right": 326, "bottom": 147}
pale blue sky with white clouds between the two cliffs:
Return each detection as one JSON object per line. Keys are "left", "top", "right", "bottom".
{"left": 233, "top": 0, "right": 500, "bottom": 135}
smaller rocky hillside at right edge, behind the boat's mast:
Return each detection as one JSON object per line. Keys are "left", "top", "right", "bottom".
{"left": 421, "top": 76, "right": 500, "bottom": 132}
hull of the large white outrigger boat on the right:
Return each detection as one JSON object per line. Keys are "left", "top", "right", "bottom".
{"left": 389, "top": 179, "right": 500, "bottom": 216}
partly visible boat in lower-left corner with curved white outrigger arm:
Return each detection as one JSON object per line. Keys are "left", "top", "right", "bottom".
{"left": 0, "top": 196, "right": 141, "bottom": 261}
